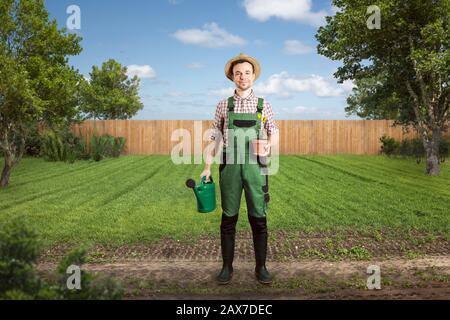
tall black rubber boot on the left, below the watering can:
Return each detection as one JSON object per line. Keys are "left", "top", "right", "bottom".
{"left": 217, "top": 214, "right": 238, "bottom": 284}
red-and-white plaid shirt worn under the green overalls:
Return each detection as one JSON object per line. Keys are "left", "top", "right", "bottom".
{"left": 211, "top": 90, "right": 278, "bottom": 146}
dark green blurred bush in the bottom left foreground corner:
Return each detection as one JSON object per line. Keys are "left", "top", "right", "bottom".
{"left": 0, "top": 221, "right": 123, "bottom": 300}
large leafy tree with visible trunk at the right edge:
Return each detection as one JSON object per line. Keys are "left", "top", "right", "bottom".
{"left": 316, "top": 0, "right": 450, "bottom": 175}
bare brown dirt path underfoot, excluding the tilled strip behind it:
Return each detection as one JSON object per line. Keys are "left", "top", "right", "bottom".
{"left": 39, "top": 256, "right": 450, "bottom": 299}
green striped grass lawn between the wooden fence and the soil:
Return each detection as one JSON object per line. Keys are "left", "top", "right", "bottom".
{"left": 0, "top": 155, "right": 450, "bottom": 245}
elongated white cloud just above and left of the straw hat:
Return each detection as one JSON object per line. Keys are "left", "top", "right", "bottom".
{"left": 173, "top": 22, "right": 246, "bottom": 48}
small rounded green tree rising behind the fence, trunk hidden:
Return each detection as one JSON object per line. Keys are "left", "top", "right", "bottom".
{"left": 82, "top": 59, "right": 143, "bottom": 120}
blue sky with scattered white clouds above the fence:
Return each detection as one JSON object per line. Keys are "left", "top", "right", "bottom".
{"left": 45, "top": 0, "right": 357, "bottom": 120}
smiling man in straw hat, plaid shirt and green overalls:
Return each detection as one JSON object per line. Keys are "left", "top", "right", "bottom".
{"left": 200, "top": 53, "right": 278, "bottom": 284}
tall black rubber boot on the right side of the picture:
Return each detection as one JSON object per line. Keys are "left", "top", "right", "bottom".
{"left": 248, "top": 215, "right": 272, "bottom": 284}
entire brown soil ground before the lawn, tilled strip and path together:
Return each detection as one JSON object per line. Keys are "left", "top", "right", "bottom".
{"left": 38, "top": 233, "right": 450, "bottom": 300}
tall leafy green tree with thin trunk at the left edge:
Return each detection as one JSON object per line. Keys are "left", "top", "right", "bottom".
{"left": 0, "top": 0, "right": 81, "bottom": 187}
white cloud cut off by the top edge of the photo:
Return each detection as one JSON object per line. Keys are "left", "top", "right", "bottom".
{"left": 243, "top": 0, "right": 327, "bottom": 26}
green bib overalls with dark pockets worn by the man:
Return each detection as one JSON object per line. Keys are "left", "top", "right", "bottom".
{"left": 219, "top": 97, "right": 269, "bottom": 218}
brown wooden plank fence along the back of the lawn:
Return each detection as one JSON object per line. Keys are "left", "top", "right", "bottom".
{"left": 73, "top": 120, "right": 450, "bottom": 155}
